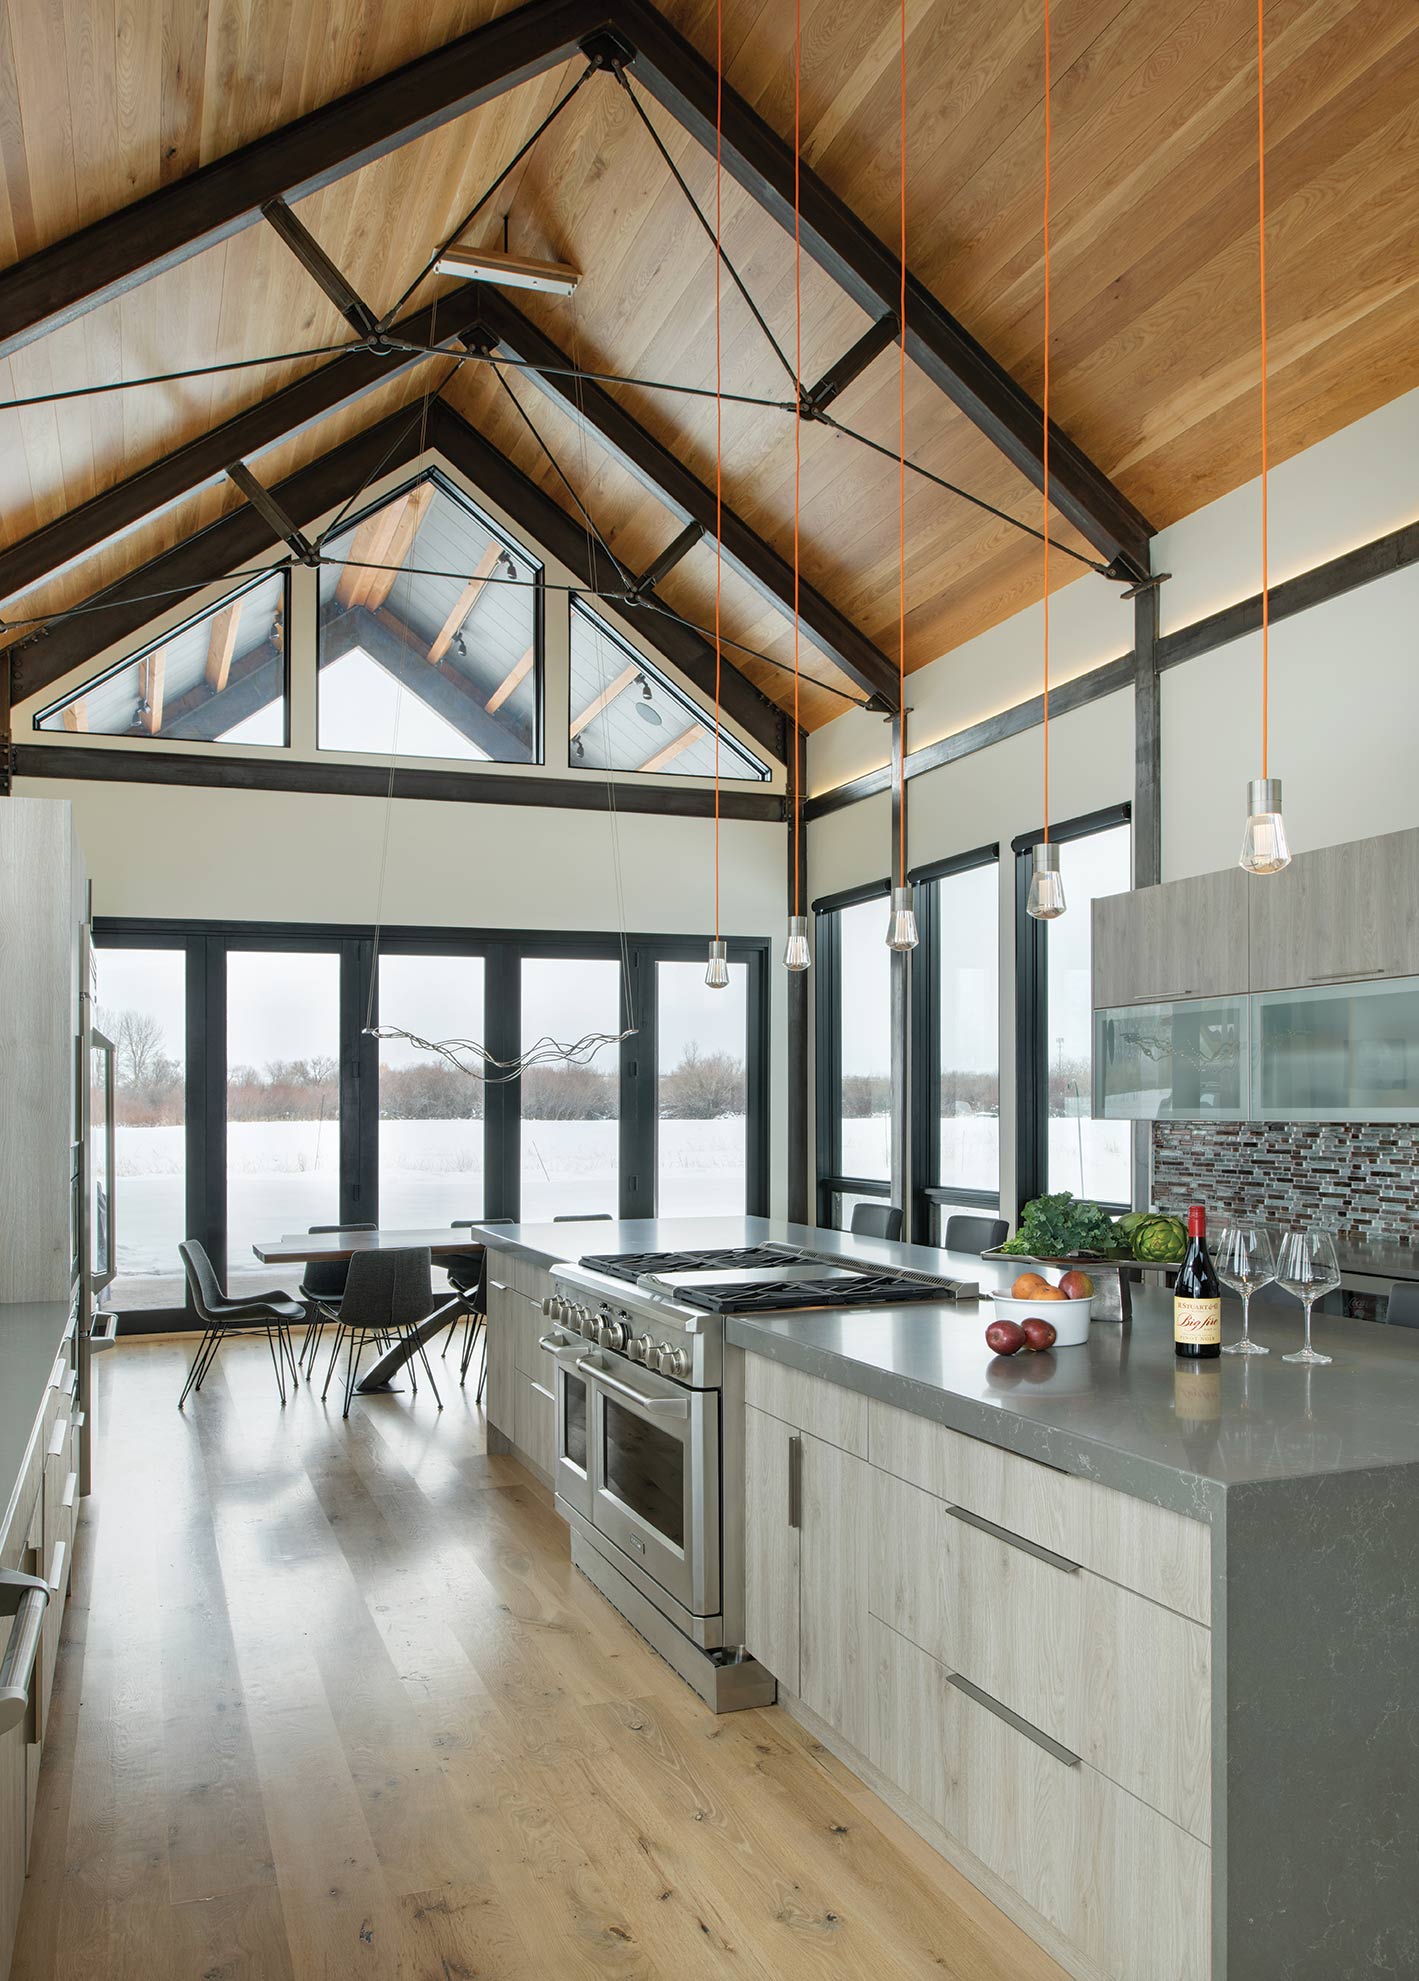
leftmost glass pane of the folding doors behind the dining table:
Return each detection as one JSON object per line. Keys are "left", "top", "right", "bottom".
{"left": 93, "top": 947, "right": 186, "bottom": 1307}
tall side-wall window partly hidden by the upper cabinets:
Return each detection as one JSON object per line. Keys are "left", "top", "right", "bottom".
{"left": 1015, "top": 806, "right": 1134, "bottom": 1208}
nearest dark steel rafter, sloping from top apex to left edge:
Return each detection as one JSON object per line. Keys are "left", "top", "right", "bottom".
{"left": 0, "top": 0, "right": 604, "bottom": 357}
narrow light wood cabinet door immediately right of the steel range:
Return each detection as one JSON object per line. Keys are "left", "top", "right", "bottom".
{"left": 743, "top": 1402, "right": 803, "bottom": 1694}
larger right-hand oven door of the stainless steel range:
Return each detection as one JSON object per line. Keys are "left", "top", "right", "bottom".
{"left": 573, "top": 1351, "right": 719, "bottom": 1616}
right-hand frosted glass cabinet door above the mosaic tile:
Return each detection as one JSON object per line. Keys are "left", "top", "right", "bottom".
{"left": 1253, "top": 977, "right": 1419, "bottom": 1121}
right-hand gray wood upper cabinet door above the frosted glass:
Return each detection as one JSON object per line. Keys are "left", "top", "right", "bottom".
{"left": 1244, "top": 832, "right": 1419, "bottom": 991}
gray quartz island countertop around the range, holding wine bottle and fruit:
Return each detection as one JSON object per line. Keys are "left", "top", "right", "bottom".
{"left": 488, "top": 1218, "right": 1419, "bottom": 1519}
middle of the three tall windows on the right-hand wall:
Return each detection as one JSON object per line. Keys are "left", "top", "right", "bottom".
{"left": 912, "top": 846, "right": 1001, "bottom": 1244}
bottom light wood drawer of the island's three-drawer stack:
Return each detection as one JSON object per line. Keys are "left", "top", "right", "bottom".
{"left": 868, "top": 1618, "right": 1211, "bottom": 1981}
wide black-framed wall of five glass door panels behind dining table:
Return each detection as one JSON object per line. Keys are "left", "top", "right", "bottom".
{"left": 95, "top": 919, "right": 769, "bottom": 1325}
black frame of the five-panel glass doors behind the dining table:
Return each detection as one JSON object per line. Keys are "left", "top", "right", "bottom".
{"left": 93, "top": 915, "right": 771, "bottom": 1333}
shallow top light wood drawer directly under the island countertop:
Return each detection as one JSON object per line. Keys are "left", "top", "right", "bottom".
{"left": 868, "top": 1403, "right": 1211, "bottom": 1622}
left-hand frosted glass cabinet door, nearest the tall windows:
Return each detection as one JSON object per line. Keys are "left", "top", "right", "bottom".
{"left": 1094, "top": 996, "right": 1247, "bottom": 1121}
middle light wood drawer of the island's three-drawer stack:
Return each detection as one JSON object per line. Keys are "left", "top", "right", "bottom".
{"left": 870, "top": 1472, "right": 1211, "bottom": 1842}
